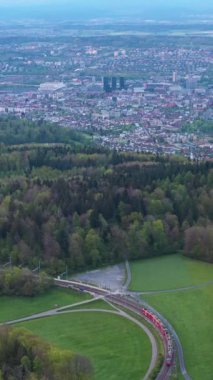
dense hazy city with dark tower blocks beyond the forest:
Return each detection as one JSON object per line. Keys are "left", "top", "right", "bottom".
{"left": 0, "top": 23, "right": 213, "bottom": 159}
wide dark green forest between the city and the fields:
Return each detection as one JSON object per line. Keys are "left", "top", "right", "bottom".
{"left": 0, "top": 117, "right": 213, "bottom": 275}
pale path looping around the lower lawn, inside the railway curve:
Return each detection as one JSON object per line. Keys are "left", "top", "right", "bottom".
{"left": 4, "top": 297, "right": 158, "bottom": 380}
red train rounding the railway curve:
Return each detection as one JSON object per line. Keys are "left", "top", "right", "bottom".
{"left": 141, "top": 308, "right": 173, "bottom": 367}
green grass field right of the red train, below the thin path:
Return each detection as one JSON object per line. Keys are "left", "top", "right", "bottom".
{"left": 143, "top": 285, "right": 213, "bottom": 380}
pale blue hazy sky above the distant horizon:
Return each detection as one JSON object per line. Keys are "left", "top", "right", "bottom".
{"left": 0, "top": 0, "right": 213, "bottom": 18}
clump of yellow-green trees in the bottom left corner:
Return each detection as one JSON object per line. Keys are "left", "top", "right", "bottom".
{"left": 0, "top": 326, "right": 92, "bottom": 380}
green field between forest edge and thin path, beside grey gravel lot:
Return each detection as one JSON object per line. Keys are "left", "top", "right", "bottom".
{"left": 130, "top": 255, "right": 213, "bottom": 291}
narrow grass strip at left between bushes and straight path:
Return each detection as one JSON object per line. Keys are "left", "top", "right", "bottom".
{"left": 0, "top": 288, "right": 91, "bottom": 322}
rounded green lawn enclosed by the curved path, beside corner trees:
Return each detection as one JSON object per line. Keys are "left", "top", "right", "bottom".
{"left": 17, "top": 312, "right": 151, "bottom": 380}
